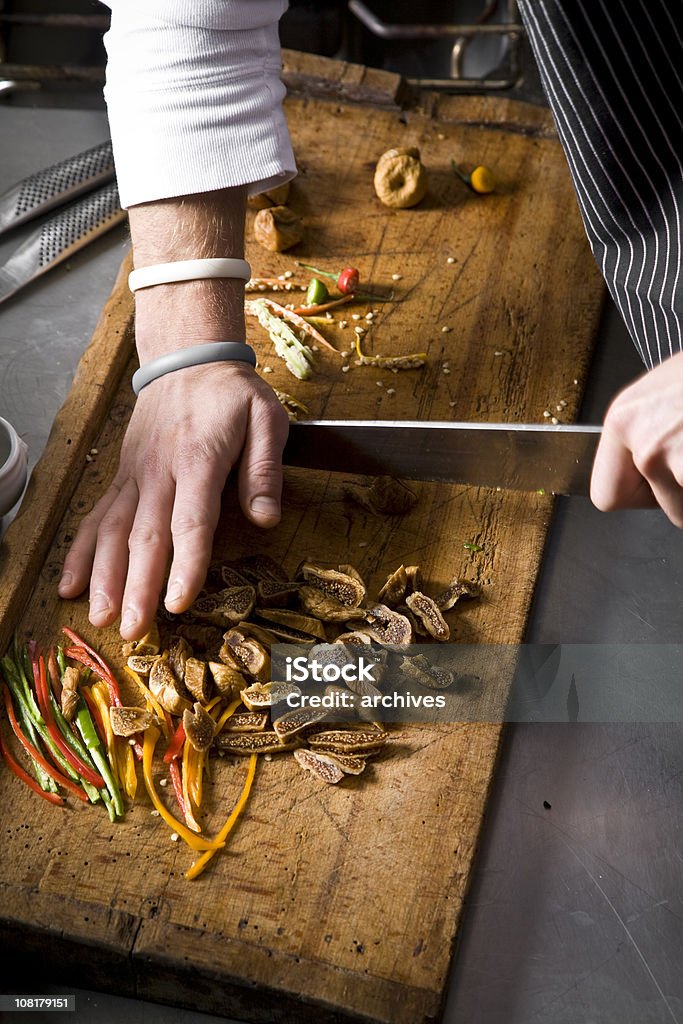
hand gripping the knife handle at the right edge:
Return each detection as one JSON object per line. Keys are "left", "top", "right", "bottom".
{"left": 591, "top": 352, "right": 683, "bottom": 527}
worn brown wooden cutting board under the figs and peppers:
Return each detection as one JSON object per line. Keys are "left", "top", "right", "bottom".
{"left": 0, "top": 54, "right": 602, "bottom": 1024}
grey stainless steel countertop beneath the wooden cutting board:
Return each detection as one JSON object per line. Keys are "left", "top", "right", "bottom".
{"left": 0, "top": 108, "right": 683, "bottom": 1024}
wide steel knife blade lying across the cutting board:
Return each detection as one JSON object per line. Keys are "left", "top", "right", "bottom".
{"left": 284, "top": 420, "right": 601, "bottom": 495}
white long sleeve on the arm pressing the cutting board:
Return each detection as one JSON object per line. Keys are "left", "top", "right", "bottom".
{"left": 100, "top": 0, "right": 296, "bottom": 207}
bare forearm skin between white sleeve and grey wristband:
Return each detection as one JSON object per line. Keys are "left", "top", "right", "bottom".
{"left": 129, "top": 186, "right": 246, "bottom": 362}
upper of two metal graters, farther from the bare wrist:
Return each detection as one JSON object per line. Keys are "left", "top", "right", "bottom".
{"left": 0, "top": 142, "right": 114, "bottom": 233}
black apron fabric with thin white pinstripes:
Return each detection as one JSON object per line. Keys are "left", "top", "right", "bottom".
{"left": 519, "top": 0, "right": 683, "bottom": 367}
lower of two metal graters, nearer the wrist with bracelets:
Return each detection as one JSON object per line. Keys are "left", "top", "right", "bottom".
{"left": 0, "top": 182, "right": 126, "bottom": 302}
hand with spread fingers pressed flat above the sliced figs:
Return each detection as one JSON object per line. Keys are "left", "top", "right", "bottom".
{"left": 59, "top": 362, "right": 288, "bottom": 640}
